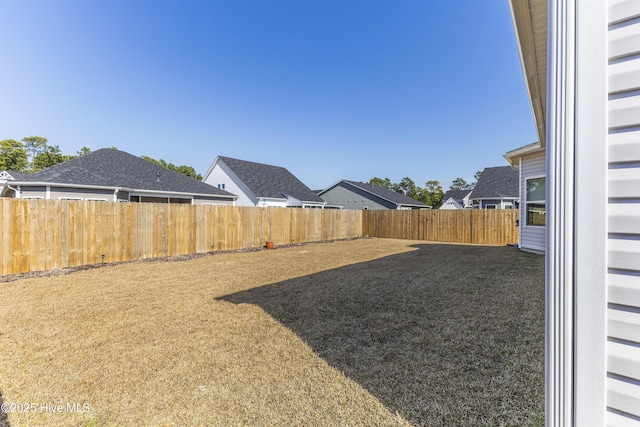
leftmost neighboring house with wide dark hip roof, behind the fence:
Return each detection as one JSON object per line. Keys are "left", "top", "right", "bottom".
{"left": 0, "top": 149, "right": 237, "bottom": 205}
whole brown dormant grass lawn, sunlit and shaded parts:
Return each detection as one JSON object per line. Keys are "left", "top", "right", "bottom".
{"left": 0, "top": 239, "right": 544, "bottom": 427}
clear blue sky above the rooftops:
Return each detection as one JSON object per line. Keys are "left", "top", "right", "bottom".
{"left": 0, "top": 0, "right": 537, "bottom": 190}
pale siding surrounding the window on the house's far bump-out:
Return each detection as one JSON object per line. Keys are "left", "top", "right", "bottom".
{"left": 520, "top": 151, "right": 547, "bottom": 251}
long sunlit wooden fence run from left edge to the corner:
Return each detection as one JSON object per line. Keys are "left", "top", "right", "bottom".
{"left": 0, "top": 198, "right": 362, "bottom": 275}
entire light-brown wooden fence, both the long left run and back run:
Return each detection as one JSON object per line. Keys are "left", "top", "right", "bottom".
{"left": 0, "top": 198, "right": 518, "bottom": 275}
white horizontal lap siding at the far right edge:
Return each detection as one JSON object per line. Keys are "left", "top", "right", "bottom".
{"left": 607, "top": 0, "right": 640, "bottom": 426}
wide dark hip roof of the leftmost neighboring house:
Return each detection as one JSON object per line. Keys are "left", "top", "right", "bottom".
{"left": 14, "top": 148, "right": 234, "bottom": 197}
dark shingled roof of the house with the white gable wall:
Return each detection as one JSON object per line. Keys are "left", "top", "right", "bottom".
{"left": 218, "top": 156, "right": 324, "bottom": 203}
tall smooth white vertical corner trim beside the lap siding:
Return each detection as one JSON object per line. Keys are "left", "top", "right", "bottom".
{"left": 545, "top": 0, "right": 607, "bottom": 426}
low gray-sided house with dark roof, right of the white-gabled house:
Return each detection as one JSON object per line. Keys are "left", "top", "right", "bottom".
{"left": 318, "top": 179, "right": 431, "bottom": 210}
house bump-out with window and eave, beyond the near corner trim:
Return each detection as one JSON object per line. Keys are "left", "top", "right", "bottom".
{"left": 504, "top": 142, "right": 547, "bottom": 252}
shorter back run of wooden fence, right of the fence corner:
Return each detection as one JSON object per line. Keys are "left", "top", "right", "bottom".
{"left": 363, "top": 209, "right": 518, "bottom": 246}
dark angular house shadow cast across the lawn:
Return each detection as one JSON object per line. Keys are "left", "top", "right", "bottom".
{"left": 221, "top": 244, "right": 544, "bottom": 426}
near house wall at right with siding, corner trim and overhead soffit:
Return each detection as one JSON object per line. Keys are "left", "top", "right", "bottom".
{"left": 510, "top": 0, "right": 640, "bottom": 426}
